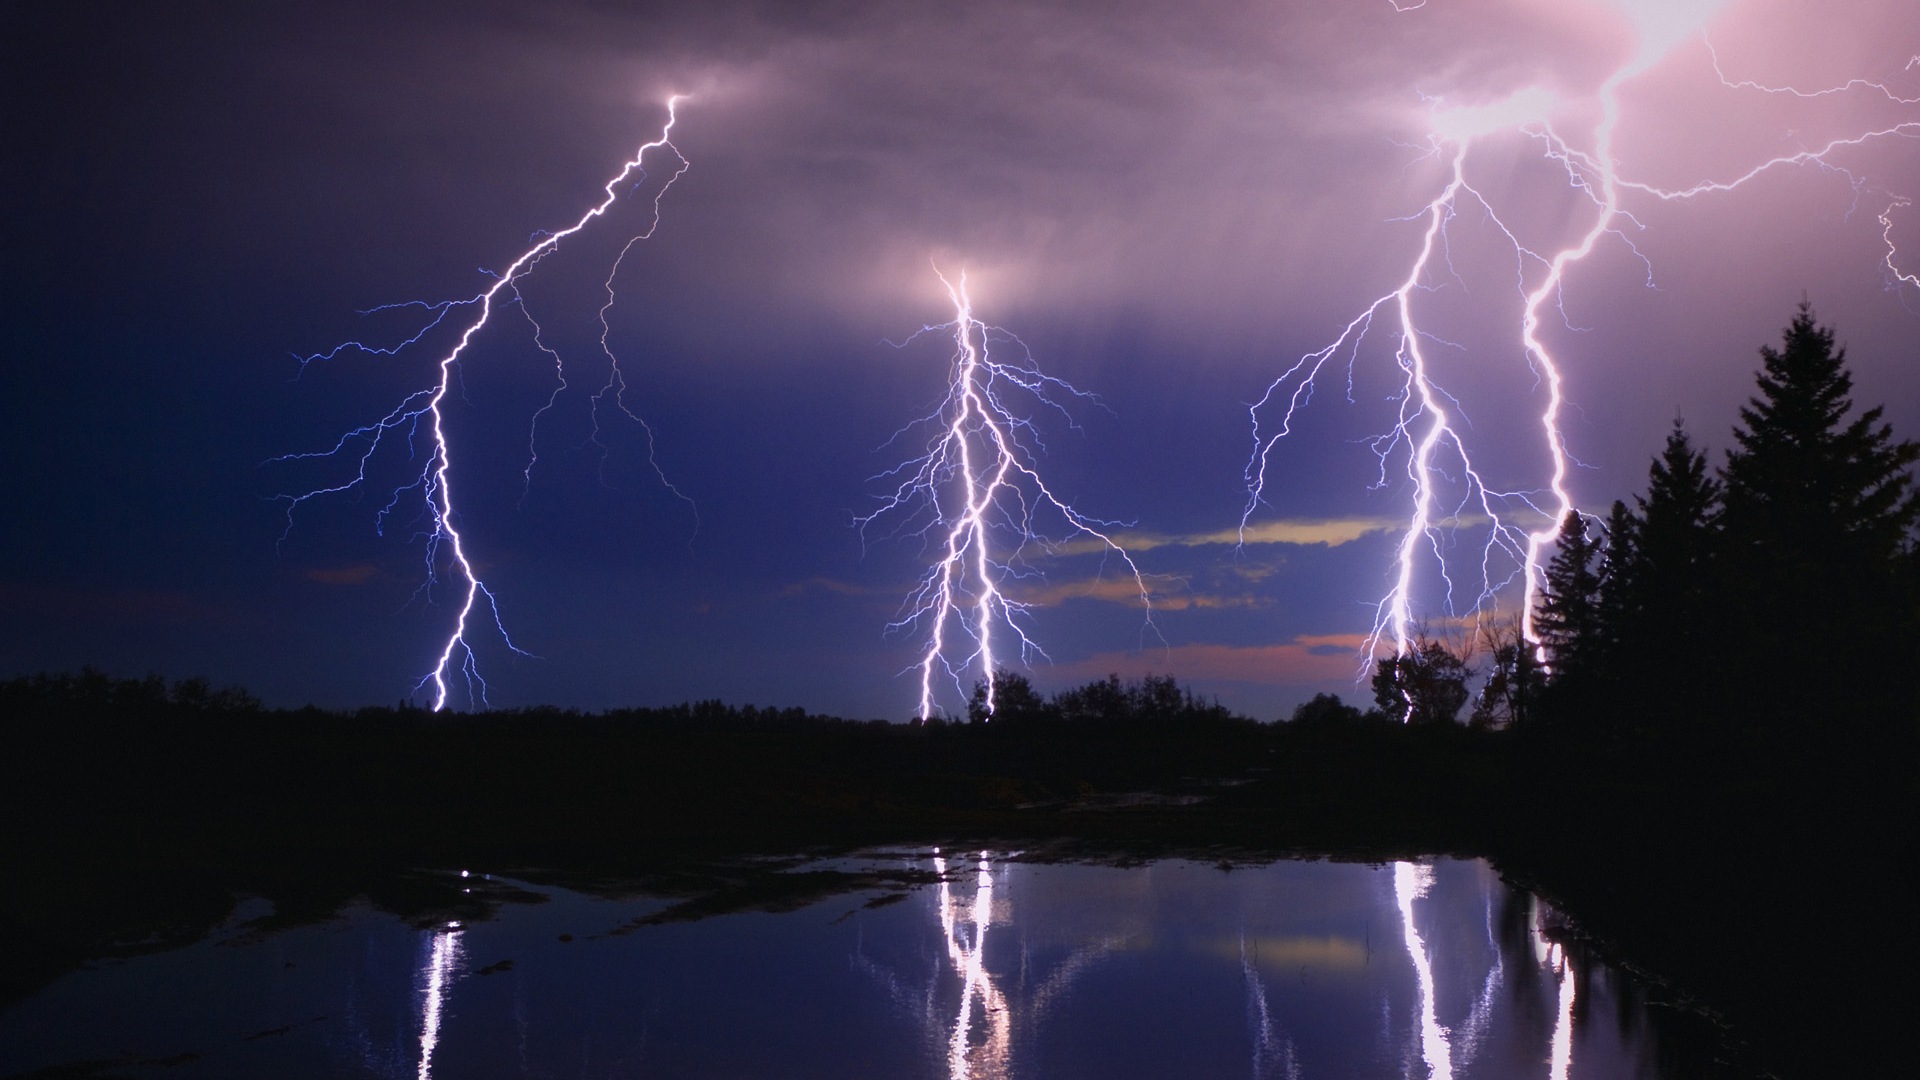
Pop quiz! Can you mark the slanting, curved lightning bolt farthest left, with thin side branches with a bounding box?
[271,94,687,711]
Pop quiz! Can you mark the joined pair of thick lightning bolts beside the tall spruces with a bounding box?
[1240,0,1920,671]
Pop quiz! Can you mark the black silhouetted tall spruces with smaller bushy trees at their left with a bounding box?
[1359,295,1920,753]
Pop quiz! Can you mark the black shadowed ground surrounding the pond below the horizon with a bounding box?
[0,684,1916,1078]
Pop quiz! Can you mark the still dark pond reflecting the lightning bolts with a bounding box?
[0,851,1689,1080]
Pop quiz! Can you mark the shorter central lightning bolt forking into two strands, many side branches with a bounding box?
[854,269,1152,719]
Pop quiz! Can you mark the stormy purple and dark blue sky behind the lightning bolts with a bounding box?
[0,0,1920,719]
